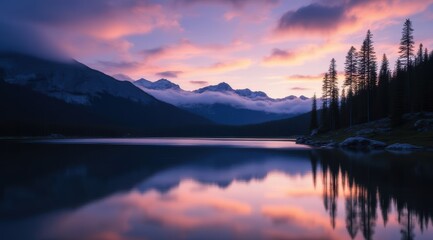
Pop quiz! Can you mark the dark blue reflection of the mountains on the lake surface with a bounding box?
[0,144,309,219]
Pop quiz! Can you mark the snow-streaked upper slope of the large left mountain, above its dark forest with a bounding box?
[0,54,157,104]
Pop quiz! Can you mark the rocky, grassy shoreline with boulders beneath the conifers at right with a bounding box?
[296,112,433,151]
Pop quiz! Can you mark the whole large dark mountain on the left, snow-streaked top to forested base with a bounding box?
[0,53,211,134]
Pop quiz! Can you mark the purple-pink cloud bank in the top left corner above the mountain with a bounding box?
[0,0,179,57]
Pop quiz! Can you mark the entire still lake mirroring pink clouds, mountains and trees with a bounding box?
[0,139,433,240]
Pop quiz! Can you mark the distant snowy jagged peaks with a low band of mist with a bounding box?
[133,79,311,125]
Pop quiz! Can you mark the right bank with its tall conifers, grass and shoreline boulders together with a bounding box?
[308,19,433,150]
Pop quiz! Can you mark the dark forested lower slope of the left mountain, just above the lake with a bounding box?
[0,82,210,136]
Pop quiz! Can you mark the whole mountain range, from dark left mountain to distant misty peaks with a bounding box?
[0,53,310,137]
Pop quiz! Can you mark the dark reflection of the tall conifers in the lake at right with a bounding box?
[312,151,433,239]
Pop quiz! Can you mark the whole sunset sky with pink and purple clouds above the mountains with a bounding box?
[0,0,433,97]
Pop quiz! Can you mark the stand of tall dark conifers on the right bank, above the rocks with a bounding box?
[312,19,433,132]
